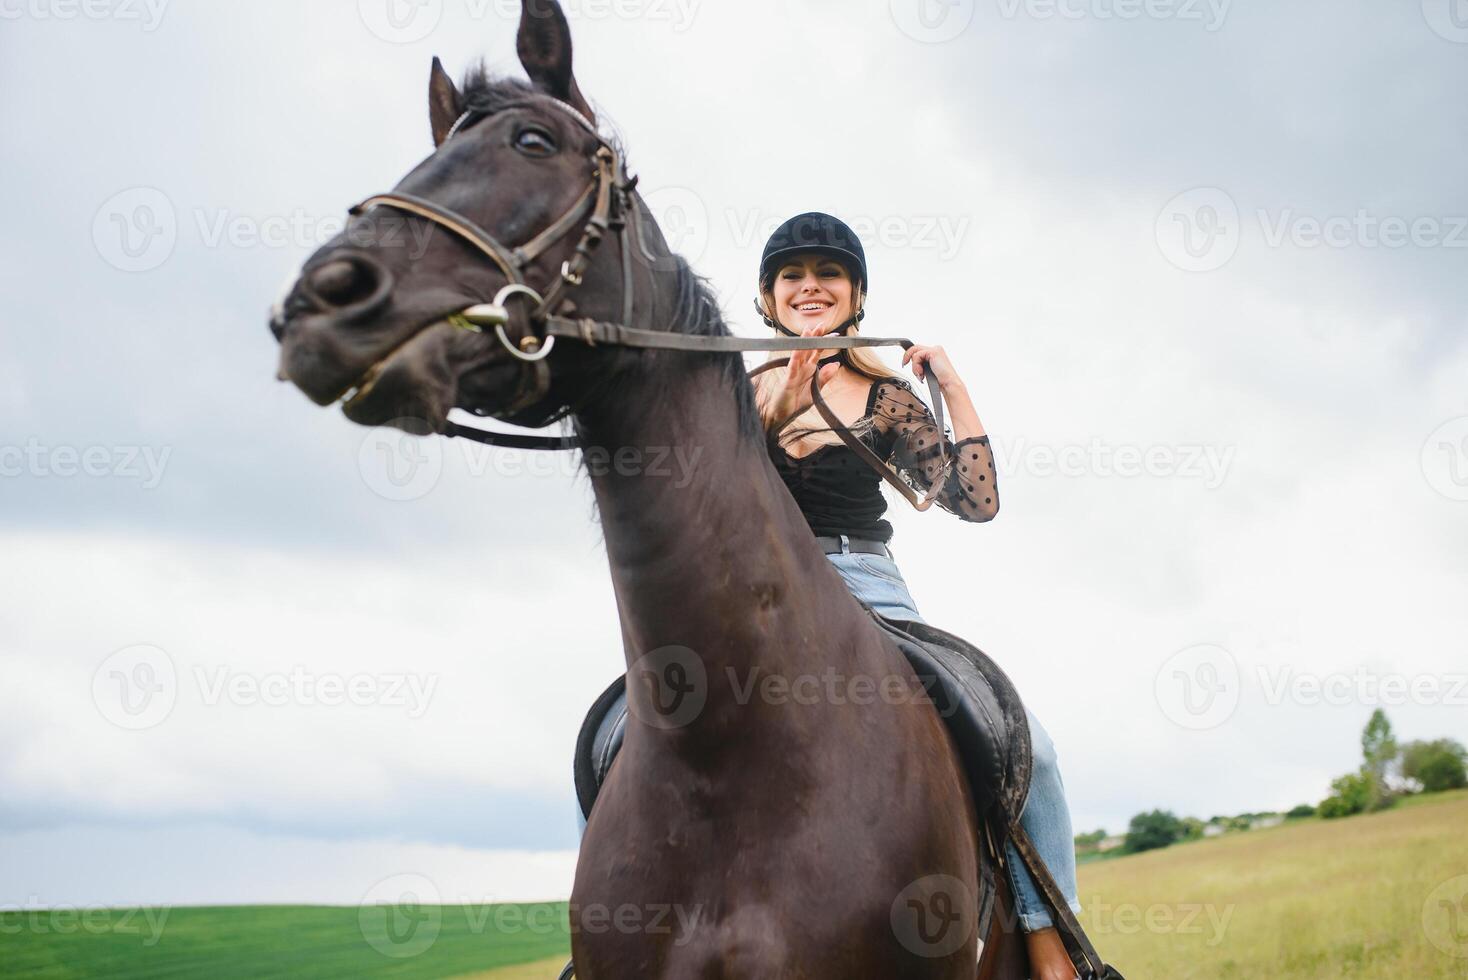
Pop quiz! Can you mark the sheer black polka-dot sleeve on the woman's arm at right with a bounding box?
[872,379,1000,522]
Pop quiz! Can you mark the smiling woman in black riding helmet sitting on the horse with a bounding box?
[756,213,1080,980]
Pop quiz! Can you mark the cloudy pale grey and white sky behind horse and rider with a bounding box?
[0,0,1468,907]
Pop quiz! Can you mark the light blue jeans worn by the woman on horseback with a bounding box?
[826,540,1080,932]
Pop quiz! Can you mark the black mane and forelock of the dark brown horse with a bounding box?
[459,60,765,440]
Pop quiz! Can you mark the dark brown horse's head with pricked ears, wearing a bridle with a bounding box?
[270,0,654,433]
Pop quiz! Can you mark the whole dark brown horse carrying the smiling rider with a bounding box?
[270,0,1028,980]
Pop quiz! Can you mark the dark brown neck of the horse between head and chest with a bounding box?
[578,355,863,712]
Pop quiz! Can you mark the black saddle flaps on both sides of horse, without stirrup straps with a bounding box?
[574,610,1031,819]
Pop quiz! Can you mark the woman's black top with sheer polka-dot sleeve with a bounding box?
[769,377,1000,543]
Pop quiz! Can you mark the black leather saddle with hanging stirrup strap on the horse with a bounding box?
[564,604,1123,980]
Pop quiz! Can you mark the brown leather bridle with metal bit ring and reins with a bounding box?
[349,100,953,511]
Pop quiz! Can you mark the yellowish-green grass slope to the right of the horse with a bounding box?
[1080,792,1468,980]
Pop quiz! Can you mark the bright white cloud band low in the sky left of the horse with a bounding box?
[0,534,621,839]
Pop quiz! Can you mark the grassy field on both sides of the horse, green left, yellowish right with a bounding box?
[11,792,1468,980]
